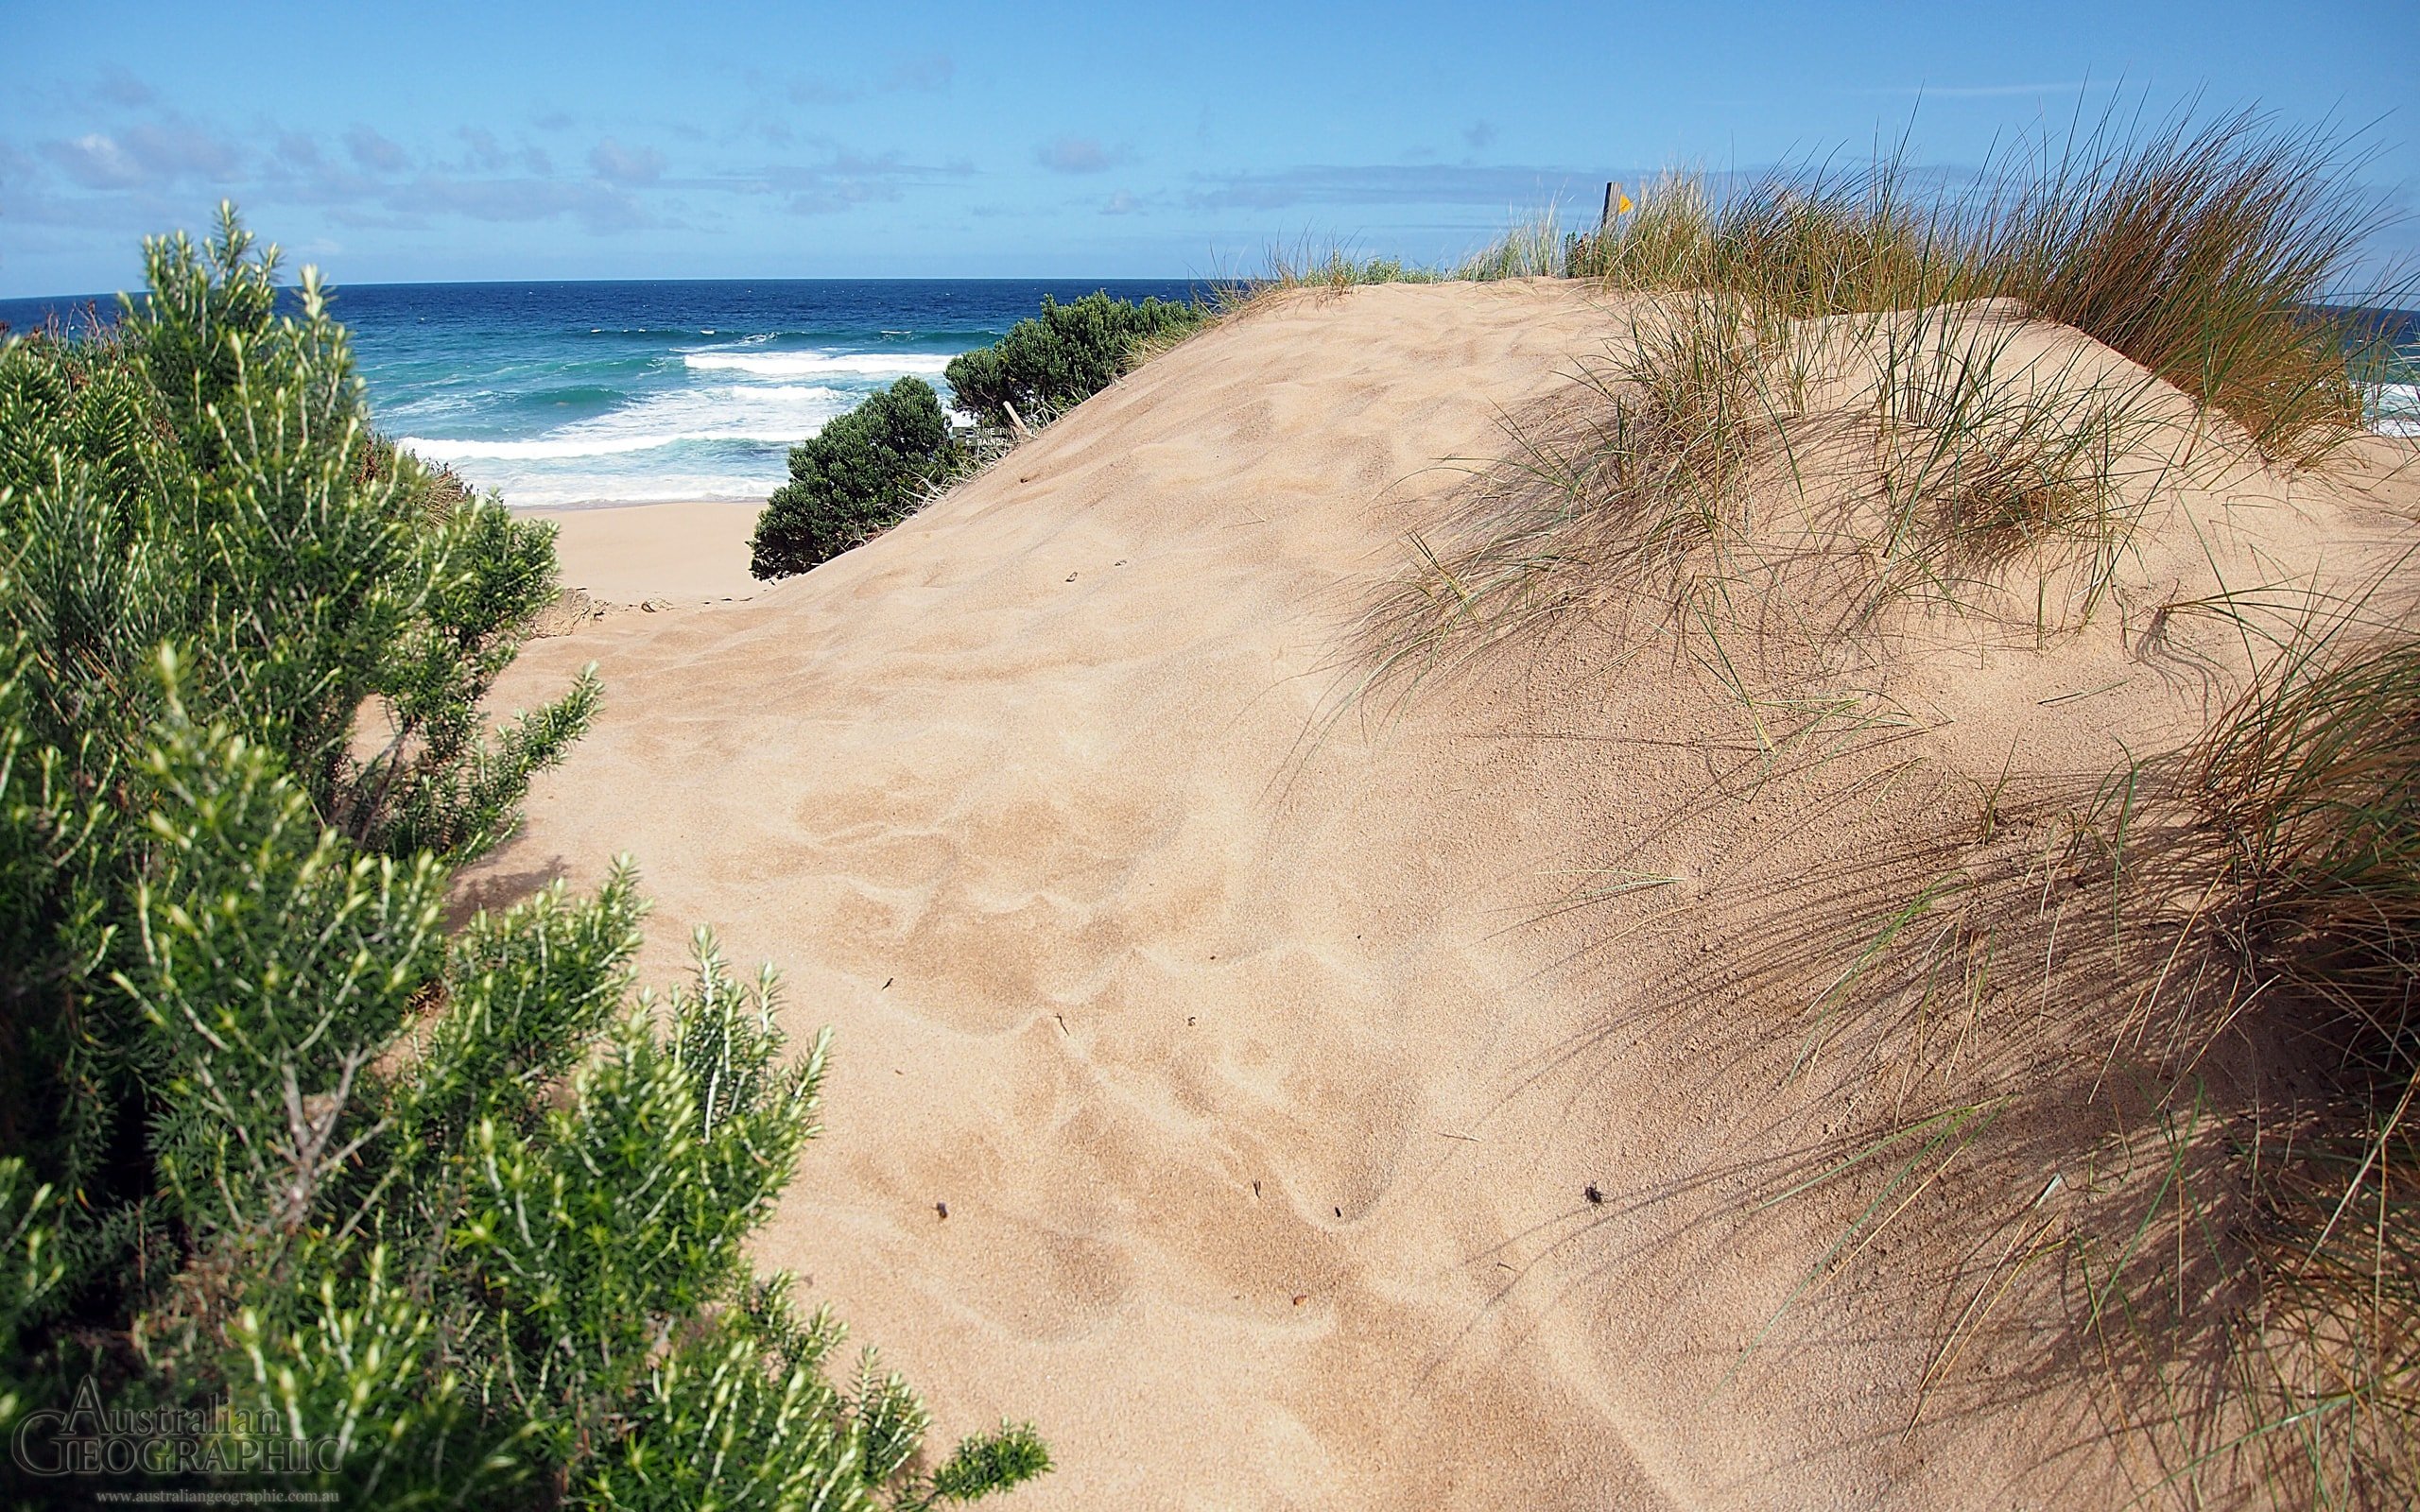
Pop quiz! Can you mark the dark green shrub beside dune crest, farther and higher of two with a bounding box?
[942,293,1210,426]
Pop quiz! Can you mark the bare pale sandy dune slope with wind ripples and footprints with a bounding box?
[470,285,2403,1507]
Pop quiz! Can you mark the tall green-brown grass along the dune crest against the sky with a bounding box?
[1564,112,2384,465]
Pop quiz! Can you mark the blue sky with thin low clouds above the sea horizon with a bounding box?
[0,0,2420,298]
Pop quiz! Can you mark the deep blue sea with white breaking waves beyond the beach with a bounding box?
[0,278,1205,508]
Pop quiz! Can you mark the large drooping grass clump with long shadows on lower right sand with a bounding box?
[1684,610,2420,1507]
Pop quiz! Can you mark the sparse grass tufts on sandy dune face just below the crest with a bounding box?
[1370,285,2183,668]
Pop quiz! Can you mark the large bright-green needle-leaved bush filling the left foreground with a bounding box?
[0,211,1047,1507]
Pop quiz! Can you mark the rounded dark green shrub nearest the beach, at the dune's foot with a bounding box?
[748,377,959,578]
